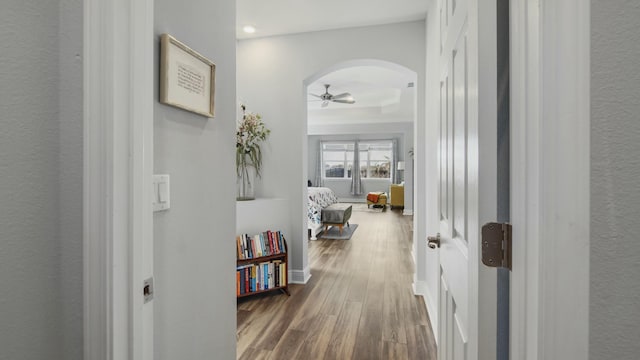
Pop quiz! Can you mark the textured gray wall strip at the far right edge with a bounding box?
[589,0,640,360]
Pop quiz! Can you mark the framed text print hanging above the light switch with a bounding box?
[160,34,216,118]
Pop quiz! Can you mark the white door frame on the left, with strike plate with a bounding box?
[83,0,154,360]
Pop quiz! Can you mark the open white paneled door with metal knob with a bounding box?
[430,0,496,360]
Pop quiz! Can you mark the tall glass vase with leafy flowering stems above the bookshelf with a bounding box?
[236,105,271,201]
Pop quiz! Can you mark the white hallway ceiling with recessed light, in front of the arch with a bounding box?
[236,0,429,39]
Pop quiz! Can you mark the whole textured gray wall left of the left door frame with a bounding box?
[0,0,82,359]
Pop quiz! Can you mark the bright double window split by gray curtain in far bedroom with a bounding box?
[322,140,393,179]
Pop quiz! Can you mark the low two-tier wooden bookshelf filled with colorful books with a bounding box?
[236,231,291,298]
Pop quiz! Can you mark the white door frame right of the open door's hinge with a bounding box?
[511,0,590,360]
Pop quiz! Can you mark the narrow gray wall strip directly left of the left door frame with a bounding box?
[58,0,84,360]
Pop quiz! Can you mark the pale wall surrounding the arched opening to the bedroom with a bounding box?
[237,21,424,278]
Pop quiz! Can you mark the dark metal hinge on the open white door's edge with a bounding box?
[482,223,511,270]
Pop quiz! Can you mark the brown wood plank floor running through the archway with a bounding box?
[237,204,436,360]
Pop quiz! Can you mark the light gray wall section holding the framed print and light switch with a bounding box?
[154,0,236,359]
